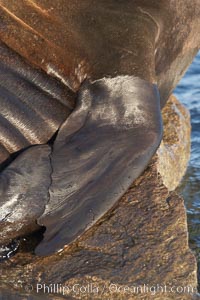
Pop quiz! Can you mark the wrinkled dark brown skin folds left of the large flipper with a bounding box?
[0,42,74,163]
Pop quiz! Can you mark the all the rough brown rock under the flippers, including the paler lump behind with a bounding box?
[0,97,198,300]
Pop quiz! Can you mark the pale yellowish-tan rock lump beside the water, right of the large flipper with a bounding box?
[157,95,191,191]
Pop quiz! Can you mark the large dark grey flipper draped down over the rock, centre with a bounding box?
[36,76,162,255]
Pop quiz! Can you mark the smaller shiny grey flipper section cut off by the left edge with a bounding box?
[0,145,52,245]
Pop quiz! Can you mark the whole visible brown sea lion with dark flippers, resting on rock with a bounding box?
[0,0,200,255]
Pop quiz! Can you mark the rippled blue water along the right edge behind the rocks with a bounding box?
[174,52,200,263]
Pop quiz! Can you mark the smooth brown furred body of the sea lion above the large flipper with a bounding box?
[0,0,200,102]
